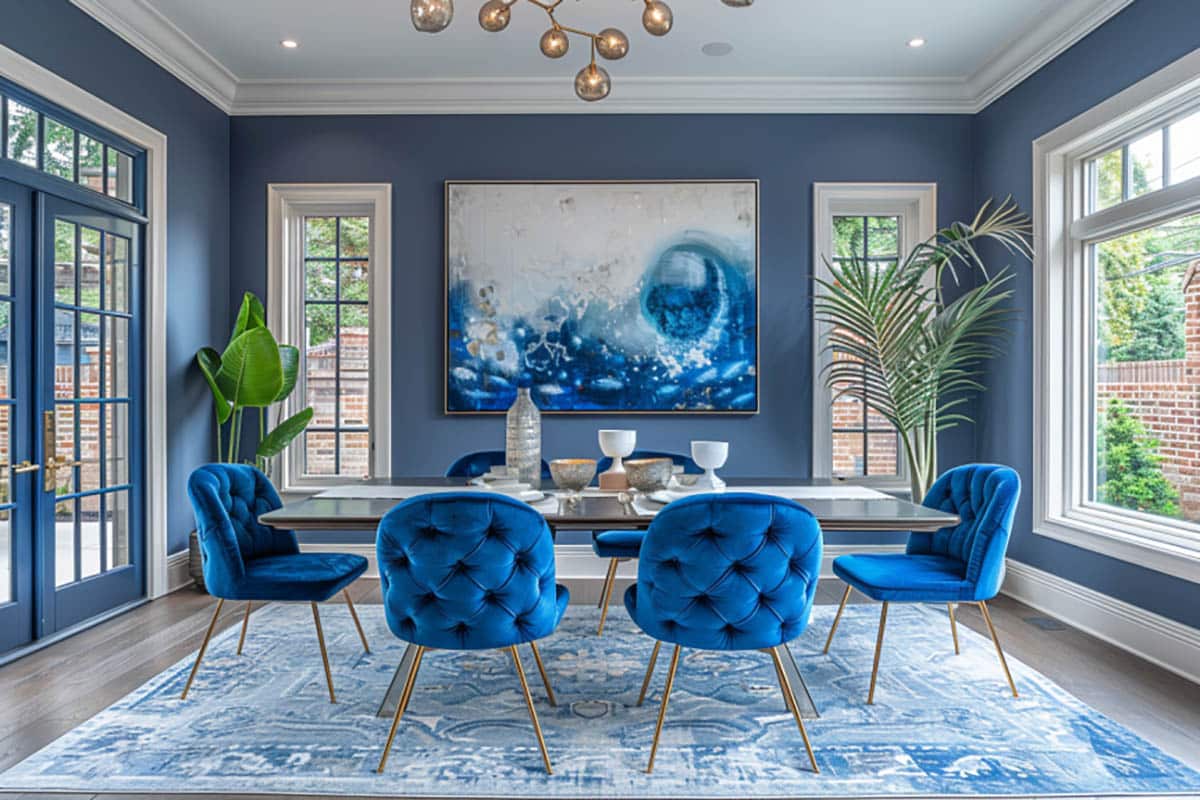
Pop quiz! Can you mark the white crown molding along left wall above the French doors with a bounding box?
[71,0,238,114]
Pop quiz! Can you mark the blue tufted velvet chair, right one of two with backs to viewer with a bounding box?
[625,493,822,772]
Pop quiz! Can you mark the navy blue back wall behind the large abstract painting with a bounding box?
[229,115,973,501]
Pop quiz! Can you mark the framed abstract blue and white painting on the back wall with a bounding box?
[446,180,758,414]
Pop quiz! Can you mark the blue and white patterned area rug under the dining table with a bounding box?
[0,603,1200,799]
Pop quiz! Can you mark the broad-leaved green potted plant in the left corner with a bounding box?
[188,291,313,589]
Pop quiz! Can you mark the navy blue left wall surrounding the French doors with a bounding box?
[0,0,229,551]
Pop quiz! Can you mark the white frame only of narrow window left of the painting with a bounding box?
[266,184,391,494]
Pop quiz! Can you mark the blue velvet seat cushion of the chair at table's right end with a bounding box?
[833,553,986,603]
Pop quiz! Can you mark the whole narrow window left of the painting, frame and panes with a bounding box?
[268,185,391,491]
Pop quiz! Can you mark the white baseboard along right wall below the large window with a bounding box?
[1002,559,1200,684]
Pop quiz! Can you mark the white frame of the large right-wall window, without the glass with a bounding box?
[1033,49,1200,582]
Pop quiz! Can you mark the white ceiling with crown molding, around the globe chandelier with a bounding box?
[73,0,1129,113]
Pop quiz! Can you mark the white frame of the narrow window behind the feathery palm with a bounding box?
[812,182,937,491]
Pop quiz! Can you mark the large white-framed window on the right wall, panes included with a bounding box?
[1033,47,1200,581]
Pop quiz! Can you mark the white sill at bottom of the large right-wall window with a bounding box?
[1034,506,1200,583]
